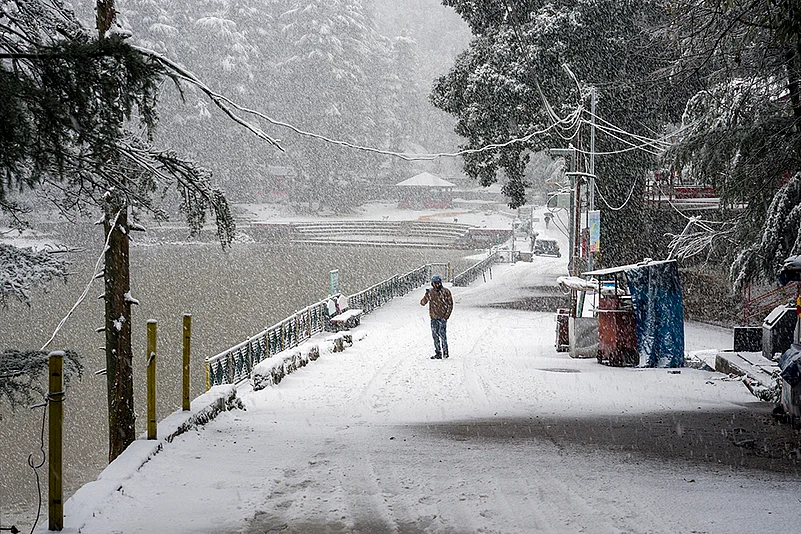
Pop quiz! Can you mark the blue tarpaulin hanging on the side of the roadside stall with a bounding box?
[626,261,684,367]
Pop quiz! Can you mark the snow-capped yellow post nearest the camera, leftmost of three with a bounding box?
[47,350,64,530]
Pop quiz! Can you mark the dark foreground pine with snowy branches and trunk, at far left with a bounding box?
[0,0,235,460]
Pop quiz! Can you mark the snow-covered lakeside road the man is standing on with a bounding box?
[56,262,801,534]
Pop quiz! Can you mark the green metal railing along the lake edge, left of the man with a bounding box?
[204,263,450,390]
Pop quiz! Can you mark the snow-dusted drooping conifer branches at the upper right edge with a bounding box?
[669,0,801,291]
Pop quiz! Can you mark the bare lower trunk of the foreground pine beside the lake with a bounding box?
[104,202,136,462]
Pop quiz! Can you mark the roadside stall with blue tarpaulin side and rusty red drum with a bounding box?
[584,260,684,367]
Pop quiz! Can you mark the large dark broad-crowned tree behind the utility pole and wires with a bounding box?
[432,0,682,265]
